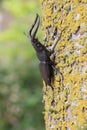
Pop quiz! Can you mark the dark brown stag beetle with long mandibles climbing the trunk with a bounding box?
[28,14,61,86]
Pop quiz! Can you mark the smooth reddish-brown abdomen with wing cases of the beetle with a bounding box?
[40,62,53,86]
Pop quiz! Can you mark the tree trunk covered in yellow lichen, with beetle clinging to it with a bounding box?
[41,0,87,130]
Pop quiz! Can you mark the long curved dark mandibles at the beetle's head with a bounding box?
[29,14,40,39]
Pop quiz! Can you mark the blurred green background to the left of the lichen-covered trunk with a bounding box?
[0,0,44,130]
